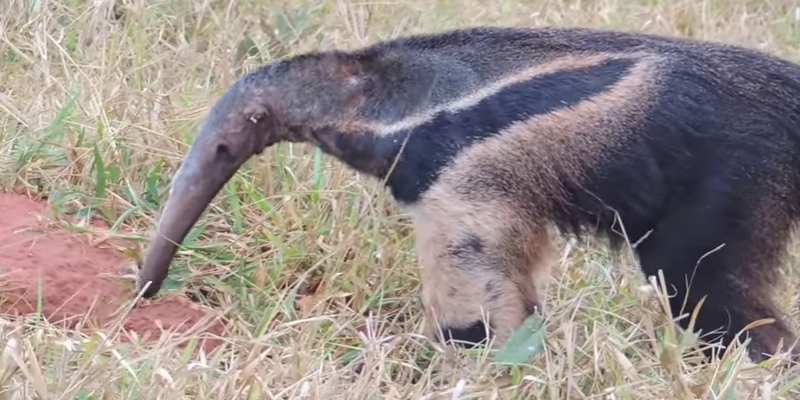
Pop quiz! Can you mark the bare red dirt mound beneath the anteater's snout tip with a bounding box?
[0,192,222,350]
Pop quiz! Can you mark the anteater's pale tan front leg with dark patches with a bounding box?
[412,197,556,346]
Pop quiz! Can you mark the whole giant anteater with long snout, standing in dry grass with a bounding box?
[134,24,800,359]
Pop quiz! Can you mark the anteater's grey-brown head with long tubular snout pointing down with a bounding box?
[137,52,371,297]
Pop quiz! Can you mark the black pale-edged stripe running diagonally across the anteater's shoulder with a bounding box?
[320,58,636,204]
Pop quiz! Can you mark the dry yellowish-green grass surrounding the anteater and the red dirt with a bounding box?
[0,0,800,400]
